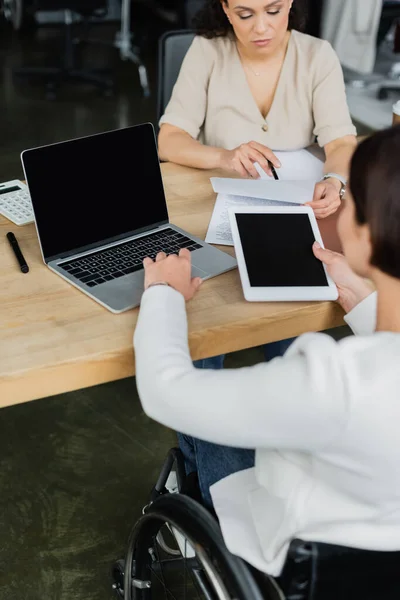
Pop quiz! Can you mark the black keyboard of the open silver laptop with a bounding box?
[58,229,202,287]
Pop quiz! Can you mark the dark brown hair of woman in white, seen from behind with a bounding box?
[349,125,400,279]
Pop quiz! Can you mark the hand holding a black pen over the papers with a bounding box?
[221,142,281,179]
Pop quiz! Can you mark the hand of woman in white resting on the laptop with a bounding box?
[143,248,203,301]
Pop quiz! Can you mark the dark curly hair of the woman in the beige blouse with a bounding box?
[192,0,307,39]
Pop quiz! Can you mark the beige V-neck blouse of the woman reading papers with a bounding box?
[160,31,356,150]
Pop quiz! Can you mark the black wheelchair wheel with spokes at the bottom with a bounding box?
[113,494,273,600]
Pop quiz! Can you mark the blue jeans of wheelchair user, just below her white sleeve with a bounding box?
[178,433,254,507]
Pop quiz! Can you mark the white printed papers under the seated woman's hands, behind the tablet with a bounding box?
[206,150,323,246]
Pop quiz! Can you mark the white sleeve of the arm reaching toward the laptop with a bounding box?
[134,286,346,451]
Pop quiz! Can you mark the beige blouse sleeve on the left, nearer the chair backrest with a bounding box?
[159,36,214,139]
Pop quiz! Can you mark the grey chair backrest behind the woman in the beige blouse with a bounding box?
[157,29,195,123]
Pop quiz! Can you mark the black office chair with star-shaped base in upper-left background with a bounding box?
[13,0,113,100]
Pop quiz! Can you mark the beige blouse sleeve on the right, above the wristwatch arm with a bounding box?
[313,41,357,147]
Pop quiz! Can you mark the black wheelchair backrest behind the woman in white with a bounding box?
[279,540,400,600]
